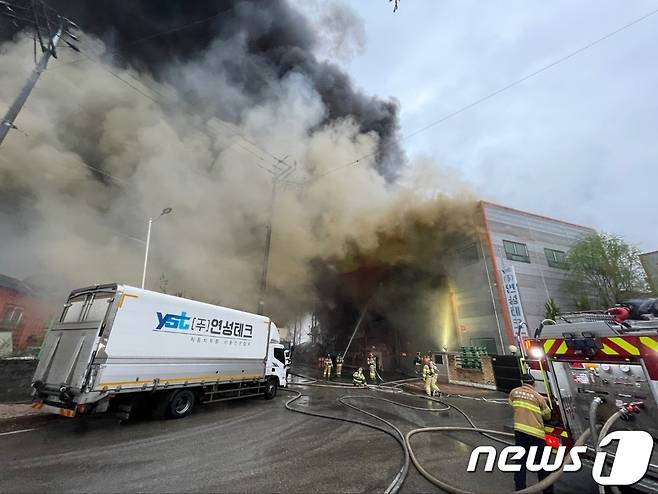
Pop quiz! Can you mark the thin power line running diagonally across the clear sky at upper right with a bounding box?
[308,9,658,185]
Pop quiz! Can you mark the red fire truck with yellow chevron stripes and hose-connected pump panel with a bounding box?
[519,312,658,492]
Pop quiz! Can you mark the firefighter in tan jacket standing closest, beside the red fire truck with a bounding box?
[509,374,553,494]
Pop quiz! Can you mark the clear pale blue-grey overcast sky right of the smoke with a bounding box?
[324,0,658,251]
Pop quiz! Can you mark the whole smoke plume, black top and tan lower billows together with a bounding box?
[0,0,474,322]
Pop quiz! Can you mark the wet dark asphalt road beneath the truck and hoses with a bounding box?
[0,368,596,494]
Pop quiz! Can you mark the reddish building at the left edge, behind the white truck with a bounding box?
[0,287,57,353]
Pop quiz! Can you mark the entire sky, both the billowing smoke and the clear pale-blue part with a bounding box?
[0,0,658,321]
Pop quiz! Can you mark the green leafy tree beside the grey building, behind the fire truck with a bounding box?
[567,233,647,308]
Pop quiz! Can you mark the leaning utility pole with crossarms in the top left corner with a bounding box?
[0,0,80,145]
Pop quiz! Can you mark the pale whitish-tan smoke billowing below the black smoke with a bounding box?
[0,29,473,320]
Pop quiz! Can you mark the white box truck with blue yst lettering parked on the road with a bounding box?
[32,284,287,418]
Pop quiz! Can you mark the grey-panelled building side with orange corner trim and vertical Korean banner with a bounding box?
[446,201,596,354]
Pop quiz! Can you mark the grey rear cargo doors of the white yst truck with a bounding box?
[34,291,114,396]
